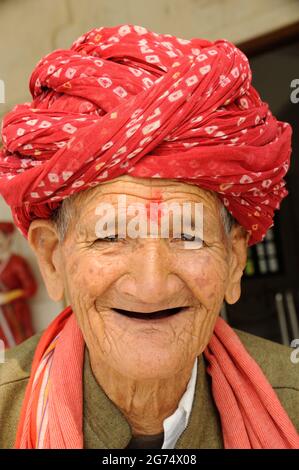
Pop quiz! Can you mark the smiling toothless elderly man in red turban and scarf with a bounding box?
[0,25,299,449]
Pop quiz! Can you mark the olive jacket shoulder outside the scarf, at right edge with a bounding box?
[234,330,299,431]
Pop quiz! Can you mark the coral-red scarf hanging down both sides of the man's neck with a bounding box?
[15,307,299,449]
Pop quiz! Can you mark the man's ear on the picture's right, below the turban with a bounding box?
[224,224,249,304]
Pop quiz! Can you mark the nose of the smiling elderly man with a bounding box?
[121,238,183,307]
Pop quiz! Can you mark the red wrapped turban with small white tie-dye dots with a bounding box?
[0,25,292,244]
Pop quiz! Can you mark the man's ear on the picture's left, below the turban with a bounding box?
[28,219,64,301]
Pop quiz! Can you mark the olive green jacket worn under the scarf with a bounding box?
[0,330,299,449]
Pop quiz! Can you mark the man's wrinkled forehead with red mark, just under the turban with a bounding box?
[68,175,223,242]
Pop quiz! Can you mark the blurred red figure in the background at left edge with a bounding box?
[0,222,37,348]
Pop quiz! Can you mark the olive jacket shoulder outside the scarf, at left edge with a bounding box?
[0,333,41,448]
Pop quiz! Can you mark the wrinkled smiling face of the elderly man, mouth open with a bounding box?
[55,176,239,379]
